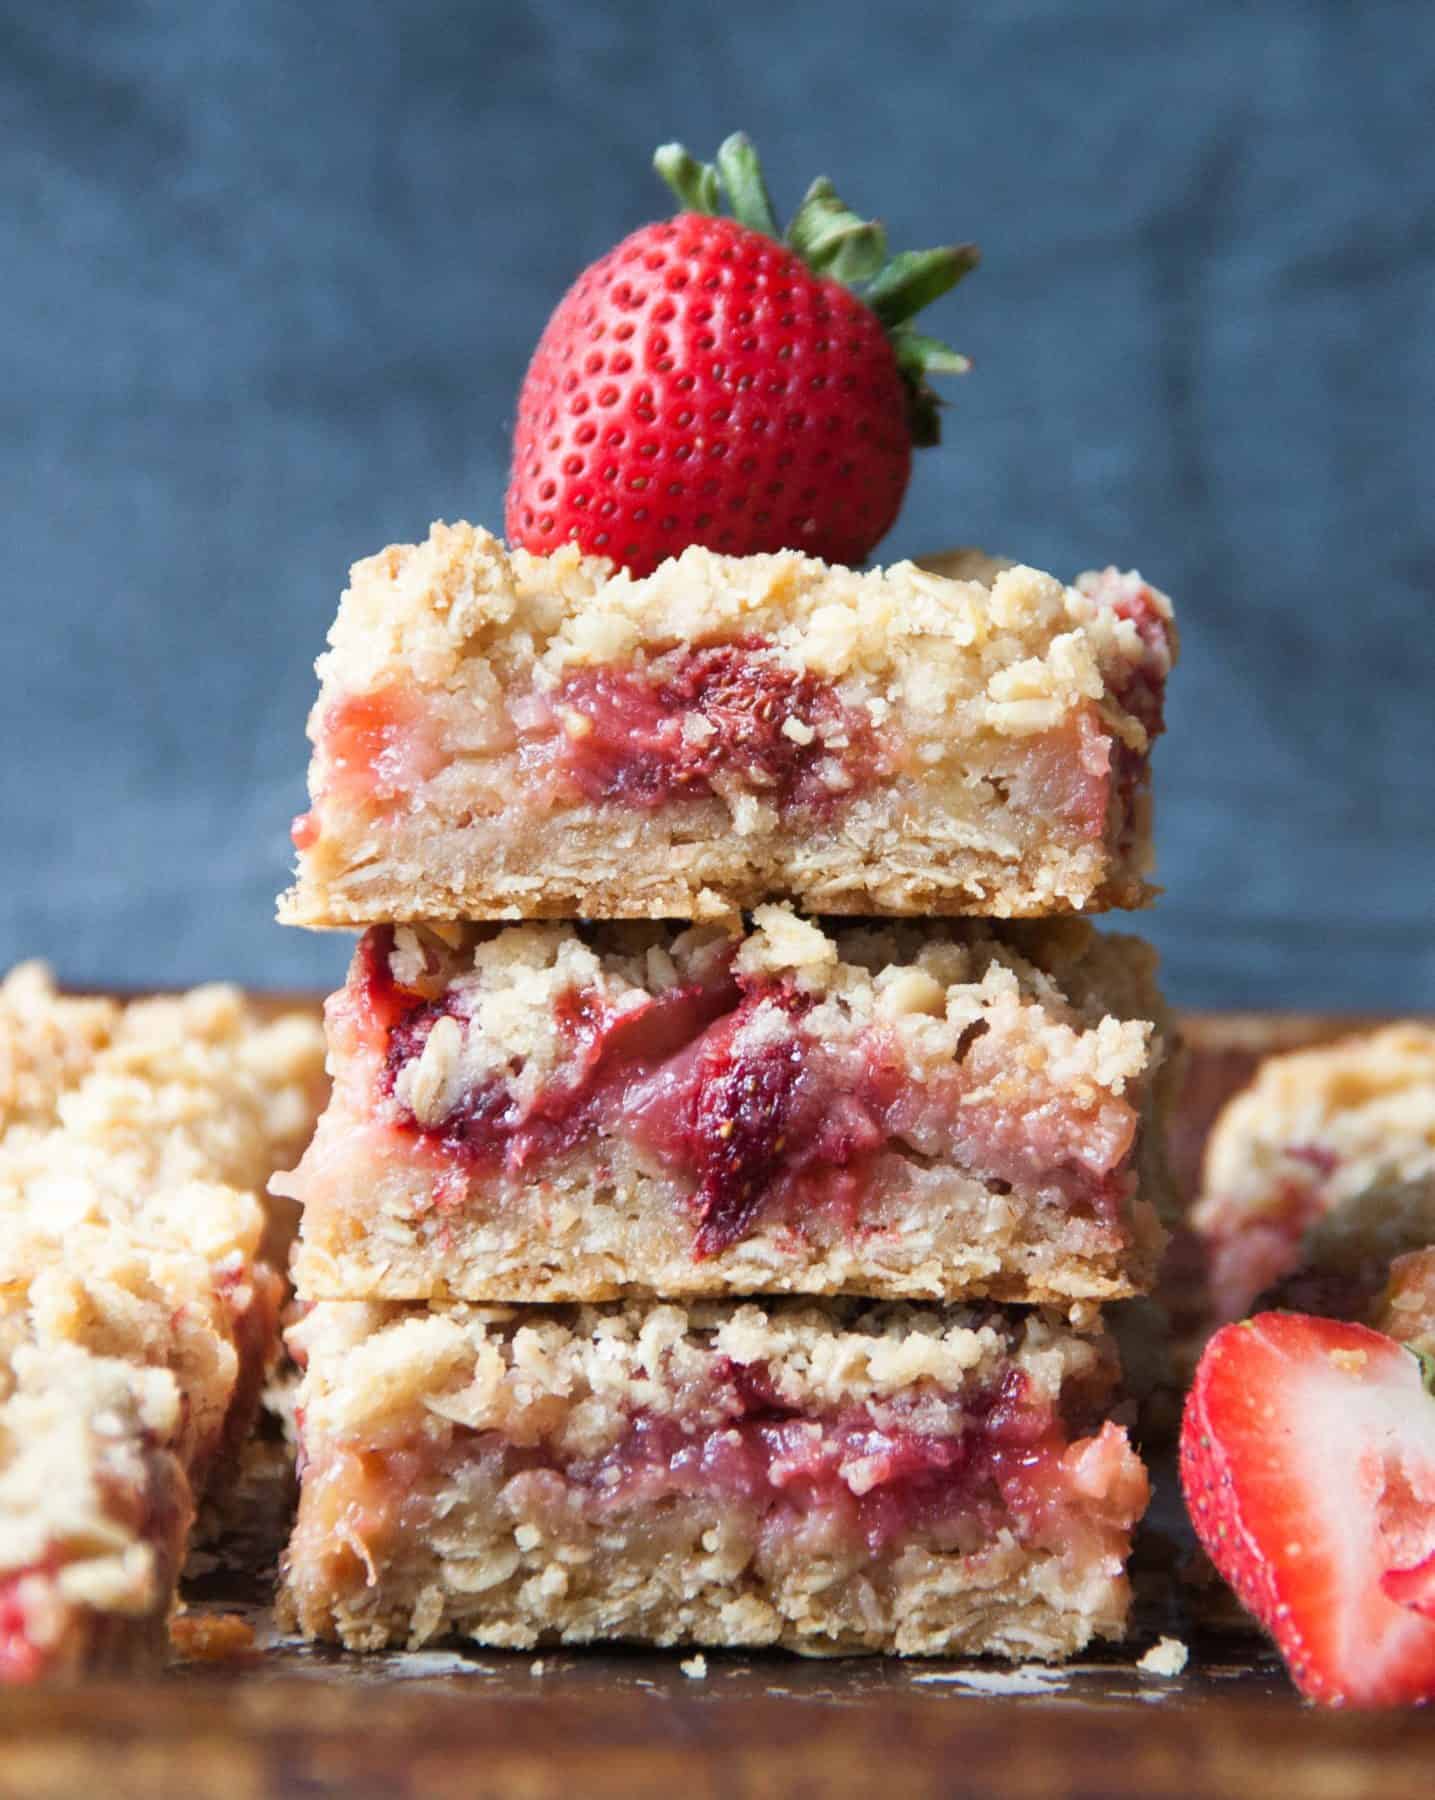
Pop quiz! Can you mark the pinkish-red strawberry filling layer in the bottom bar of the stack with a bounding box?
[304,1359,1149,1568]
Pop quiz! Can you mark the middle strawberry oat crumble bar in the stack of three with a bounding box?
[286,907,1165,1305]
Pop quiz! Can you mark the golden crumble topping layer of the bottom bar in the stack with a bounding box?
[290,1300,1113,1456]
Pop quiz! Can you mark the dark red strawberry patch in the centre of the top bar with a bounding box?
[542,637,880,812]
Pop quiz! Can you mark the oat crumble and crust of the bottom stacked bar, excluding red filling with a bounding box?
[281,1301,1147,1660]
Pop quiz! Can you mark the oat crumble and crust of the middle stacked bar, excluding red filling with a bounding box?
[286,907,1170,1305]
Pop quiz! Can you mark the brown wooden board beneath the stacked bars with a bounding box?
[0,1013,1435,1800]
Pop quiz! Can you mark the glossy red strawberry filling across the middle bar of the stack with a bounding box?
[358,929,1138,1258]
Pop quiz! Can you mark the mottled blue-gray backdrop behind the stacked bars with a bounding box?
[0,0,1435,1006]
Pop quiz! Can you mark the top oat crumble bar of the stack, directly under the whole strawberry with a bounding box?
[281,524,1174,925]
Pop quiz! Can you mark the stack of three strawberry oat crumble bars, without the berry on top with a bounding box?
[271,526,1174,1658]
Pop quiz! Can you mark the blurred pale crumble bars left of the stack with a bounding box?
[0,965,322,1679]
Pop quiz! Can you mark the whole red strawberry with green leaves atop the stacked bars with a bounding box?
[506,135,978,574]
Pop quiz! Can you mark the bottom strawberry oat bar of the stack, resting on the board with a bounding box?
[283,1300,1149,1660]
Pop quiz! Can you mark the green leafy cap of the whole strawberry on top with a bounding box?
[654,131,981,445]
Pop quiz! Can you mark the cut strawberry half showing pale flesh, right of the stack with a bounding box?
[1181,1312,1435,1706]
